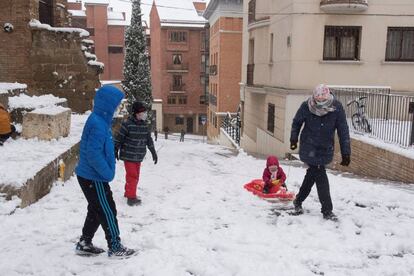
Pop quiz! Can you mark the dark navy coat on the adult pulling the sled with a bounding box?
[290,100,351,165]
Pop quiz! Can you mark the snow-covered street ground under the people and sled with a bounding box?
[0,135,414,276]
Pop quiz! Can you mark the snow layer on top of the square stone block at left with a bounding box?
[9,94,66,110]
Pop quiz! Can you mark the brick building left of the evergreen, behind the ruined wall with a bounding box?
[68,0,129,80]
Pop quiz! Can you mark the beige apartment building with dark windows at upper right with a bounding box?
[240,0,414,156]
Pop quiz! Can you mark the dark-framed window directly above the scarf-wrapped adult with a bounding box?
[323,26,361,60]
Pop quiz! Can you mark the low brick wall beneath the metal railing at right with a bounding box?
[331,139,414,183]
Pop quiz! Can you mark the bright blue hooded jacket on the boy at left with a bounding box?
[75,86,124,182]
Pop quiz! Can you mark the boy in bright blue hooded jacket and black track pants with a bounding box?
[75,86,135,257]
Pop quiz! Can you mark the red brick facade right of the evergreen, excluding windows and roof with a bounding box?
[150,3,207,133]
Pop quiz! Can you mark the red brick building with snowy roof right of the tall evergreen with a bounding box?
[150,0,209,134]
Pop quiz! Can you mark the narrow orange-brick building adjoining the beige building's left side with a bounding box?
[204,0,243,140]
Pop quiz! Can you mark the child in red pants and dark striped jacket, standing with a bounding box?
[115,102,158,206]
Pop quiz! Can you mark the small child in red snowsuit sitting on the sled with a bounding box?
[262,155,287,194]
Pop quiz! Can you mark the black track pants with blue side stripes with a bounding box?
[78,176,120,249]
